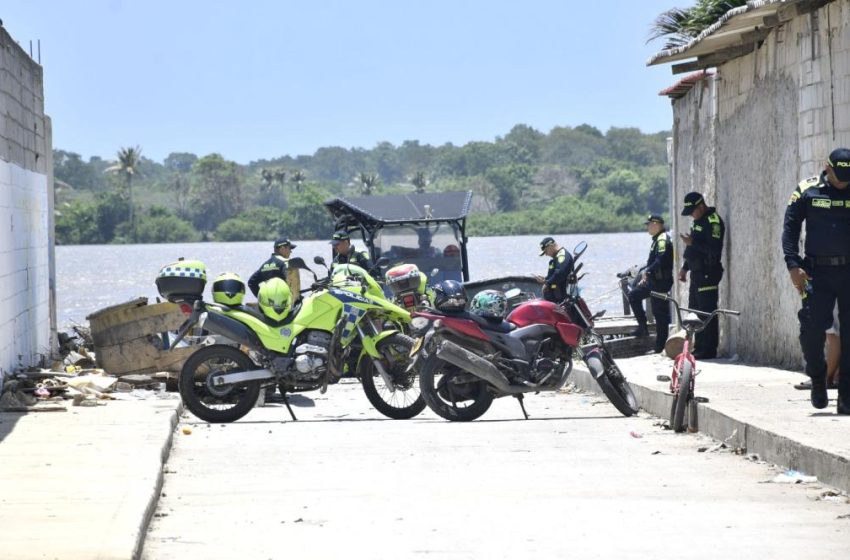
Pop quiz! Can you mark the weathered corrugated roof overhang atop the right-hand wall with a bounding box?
[647,0,820,72]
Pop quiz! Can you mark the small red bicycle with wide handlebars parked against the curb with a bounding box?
[650,292,741,432]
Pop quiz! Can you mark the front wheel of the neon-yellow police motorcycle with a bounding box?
[359,333,425,420]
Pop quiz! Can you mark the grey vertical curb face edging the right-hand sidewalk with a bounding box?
[570,364,850,492]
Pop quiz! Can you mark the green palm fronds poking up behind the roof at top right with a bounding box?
[649,0,747,49]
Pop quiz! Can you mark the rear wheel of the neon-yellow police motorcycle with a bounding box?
[178,345,260,423]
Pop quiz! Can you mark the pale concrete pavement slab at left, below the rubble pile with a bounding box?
[0,393,180,560]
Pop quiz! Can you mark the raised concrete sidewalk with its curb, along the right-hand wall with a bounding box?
[573,354,850,491]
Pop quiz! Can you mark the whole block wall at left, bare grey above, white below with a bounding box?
[0,27,55,383]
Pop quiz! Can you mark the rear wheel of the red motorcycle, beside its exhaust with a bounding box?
[419,354,493,422]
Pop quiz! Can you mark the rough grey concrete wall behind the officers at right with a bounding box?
[672,0,850,367]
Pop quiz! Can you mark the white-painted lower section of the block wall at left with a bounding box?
[0,160,50,372]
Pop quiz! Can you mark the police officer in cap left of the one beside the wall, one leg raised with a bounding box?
[629,214,673,352]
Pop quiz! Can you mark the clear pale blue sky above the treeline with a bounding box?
[0,0,692,164]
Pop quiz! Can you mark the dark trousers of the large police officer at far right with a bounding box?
[797,265,850,403]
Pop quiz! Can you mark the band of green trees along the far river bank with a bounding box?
[54,124,668,244]
